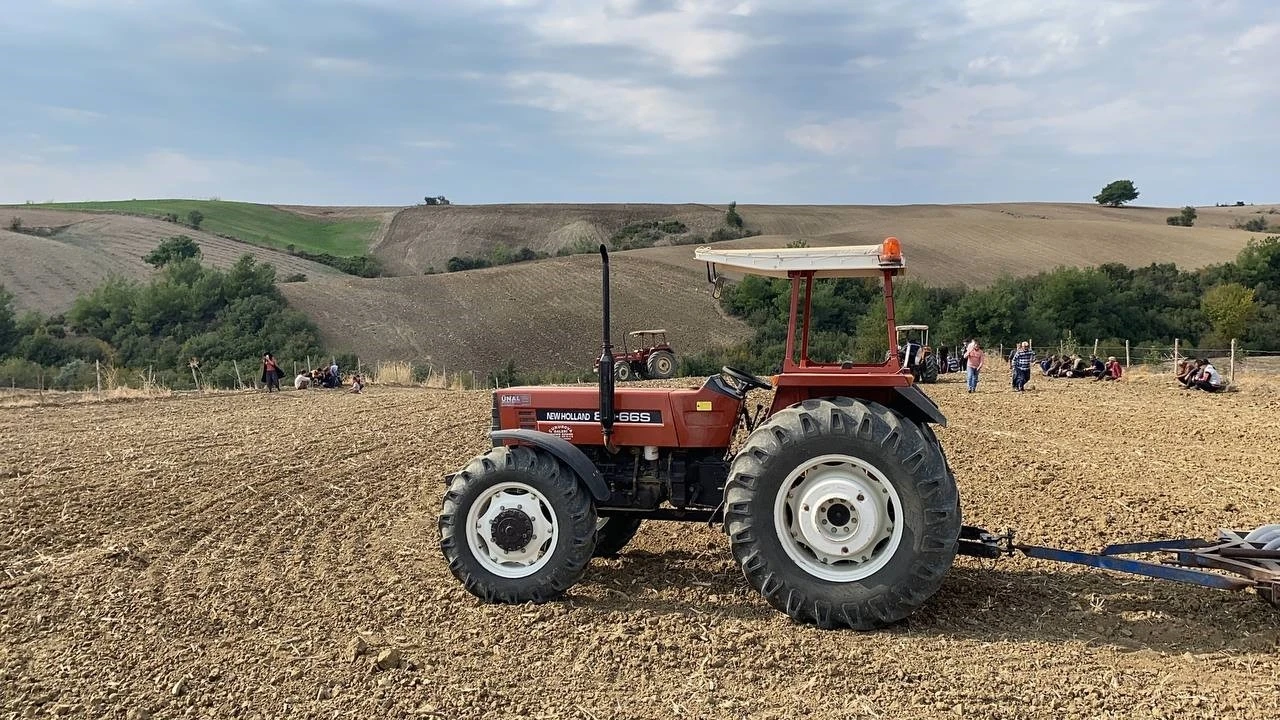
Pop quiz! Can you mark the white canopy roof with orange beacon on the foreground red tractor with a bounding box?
[694,237,906,278]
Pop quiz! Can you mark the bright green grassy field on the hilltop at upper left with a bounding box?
[8,200,397,256]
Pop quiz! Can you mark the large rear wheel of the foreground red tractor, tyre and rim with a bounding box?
[724,397,960,630]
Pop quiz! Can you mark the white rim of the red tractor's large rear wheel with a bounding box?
[773,455,902,583]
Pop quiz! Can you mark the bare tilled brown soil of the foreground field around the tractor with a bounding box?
[0,372,1280,719]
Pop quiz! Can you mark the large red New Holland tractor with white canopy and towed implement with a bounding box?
[439,237,1280,629]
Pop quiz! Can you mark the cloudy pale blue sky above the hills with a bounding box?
[0,0,1280,205]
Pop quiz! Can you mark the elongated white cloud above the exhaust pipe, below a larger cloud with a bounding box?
[507,73,716,141]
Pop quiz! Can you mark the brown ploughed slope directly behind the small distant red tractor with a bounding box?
[280,247,750,374]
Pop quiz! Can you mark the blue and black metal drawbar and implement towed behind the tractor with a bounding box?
[959,525,1280,607]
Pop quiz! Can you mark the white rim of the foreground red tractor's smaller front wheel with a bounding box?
[467,483,559,578]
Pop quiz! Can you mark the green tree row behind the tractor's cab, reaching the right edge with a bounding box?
[682,236,1280,374]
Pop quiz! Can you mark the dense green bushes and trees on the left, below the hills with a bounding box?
[0,236,321,387]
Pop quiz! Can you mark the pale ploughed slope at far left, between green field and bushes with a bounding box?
[0,208,339,313]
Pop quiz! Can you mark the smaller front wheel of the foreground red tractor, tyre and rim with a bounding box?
[439,446,596,603]
